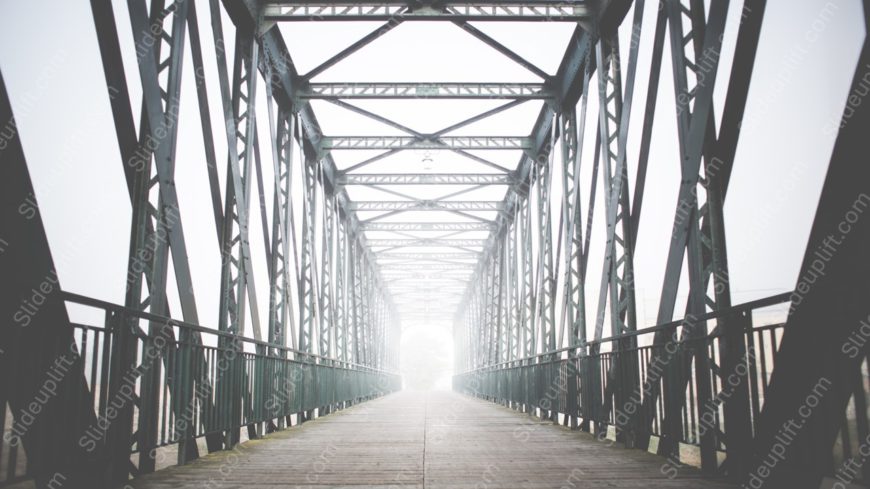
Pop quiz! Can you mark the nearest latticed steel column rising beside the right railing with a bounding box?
[659,0,730,472]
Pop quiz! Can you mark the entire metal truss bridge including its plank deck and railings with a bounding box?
[0,0,870,489]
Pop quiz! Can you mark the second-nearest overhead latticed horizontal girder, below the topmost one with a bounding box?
[300,82,551,100]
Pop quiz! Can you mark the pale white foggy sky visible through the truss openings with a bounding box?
[0,0,864,384]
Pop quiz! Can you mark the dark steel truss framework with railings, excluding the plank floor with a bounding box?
[0,0,870,487]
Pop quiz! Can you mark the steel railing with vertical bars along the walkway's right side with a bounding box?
[453,293,790,470]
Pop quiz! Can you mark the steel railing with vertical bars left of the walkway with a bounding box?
[0,292,401,486]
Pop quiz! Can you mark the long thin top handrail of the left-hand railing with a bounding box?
[58,290,399,375]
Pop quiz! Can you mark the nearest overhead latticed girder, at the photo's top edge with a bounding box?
[263,0,590,22]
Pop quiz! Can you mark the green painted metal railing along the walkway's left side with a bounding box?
[62,292,402,462]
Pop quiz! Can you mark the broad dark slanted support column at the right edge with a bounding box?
[745,32,870,489]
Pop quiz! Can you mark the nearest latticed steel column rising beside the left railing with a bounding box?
[126,0,197,473]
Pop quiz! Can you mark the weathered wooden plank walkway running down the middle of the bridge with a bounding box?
[128,392,736,489]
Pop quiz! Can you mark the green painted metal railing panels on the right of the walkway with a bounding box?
[453,294,790,468]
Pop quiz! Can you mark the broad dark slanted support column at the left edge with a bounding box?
[0,70,104,487]
